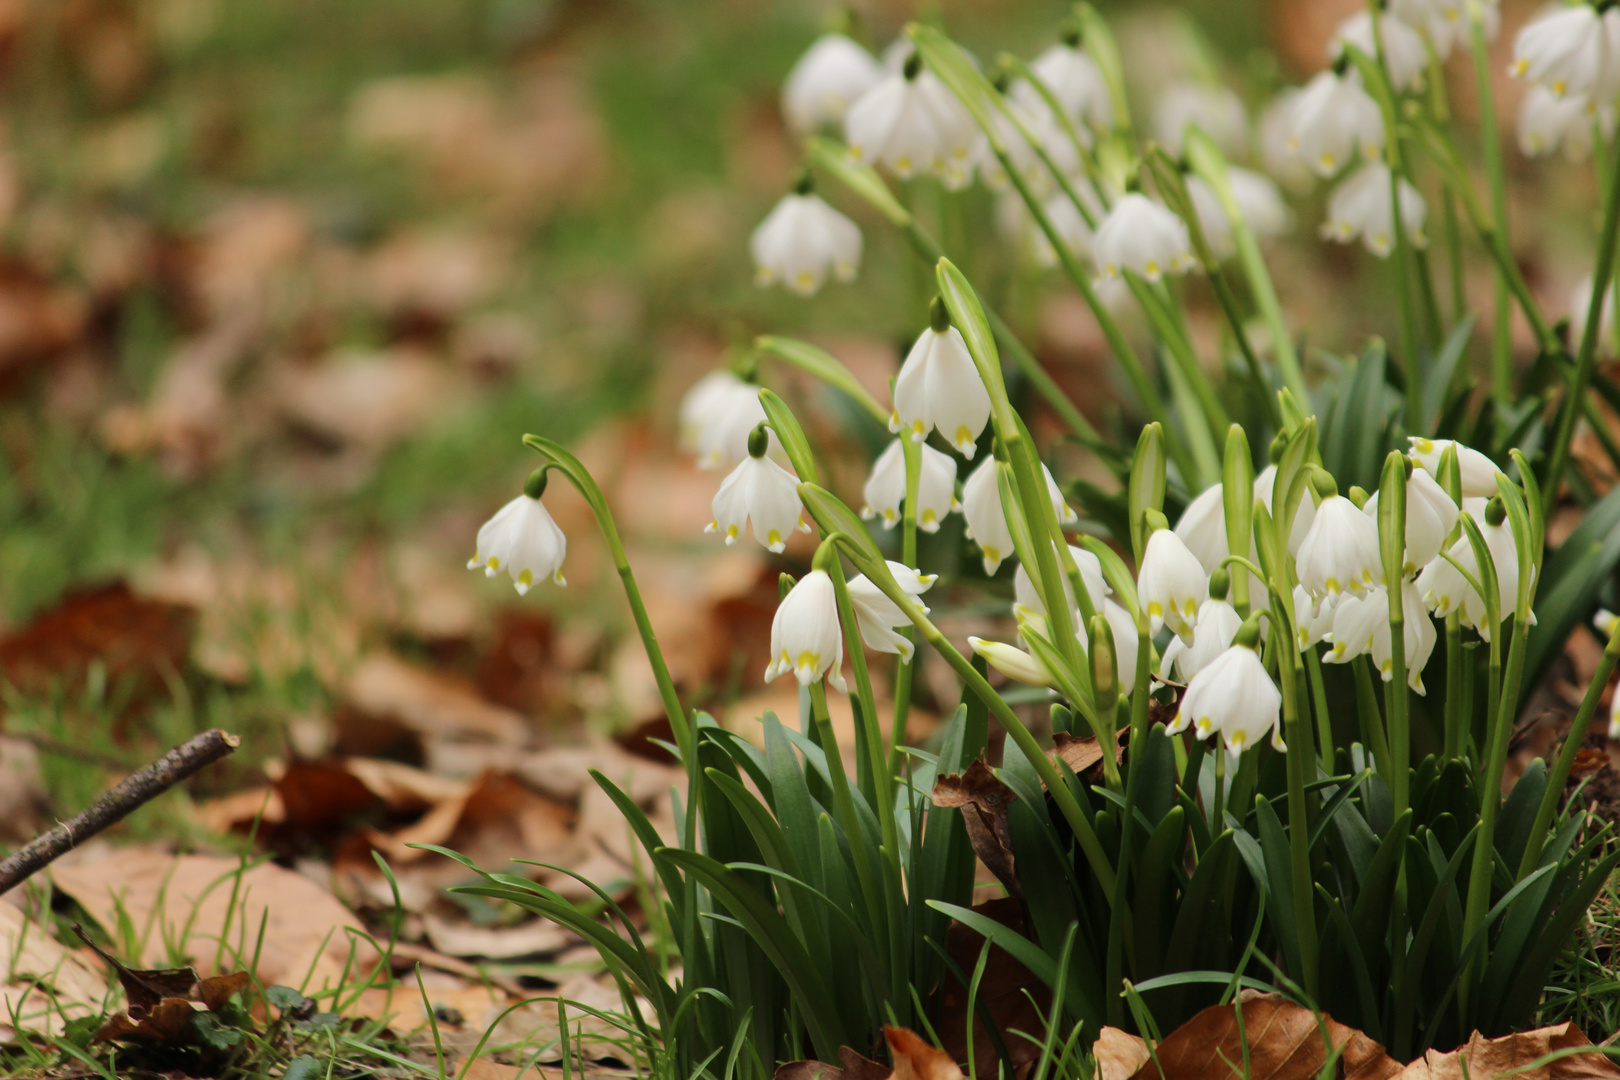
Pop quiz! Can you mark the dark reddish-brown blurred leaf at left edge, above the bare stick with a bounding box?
[0,581,194,701]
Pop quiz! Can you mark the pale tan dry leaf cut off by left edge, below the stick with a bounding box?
[0,900,107,1043]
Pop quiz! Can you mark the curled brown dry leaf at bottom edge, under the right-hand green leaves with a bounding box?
[1132,994,1401,1080]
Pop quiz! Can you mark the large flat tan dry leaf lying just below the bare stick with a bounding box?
[50,847,376,993]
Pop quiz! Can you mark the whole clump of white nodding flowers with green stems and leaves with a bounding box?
[447,0,1620,1077]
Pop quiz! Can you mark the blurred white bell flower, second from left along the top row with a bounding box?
[844,58,978,189]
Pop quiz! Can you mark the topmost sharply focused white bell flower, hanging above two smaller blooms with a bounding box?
[889,318,990,461]
